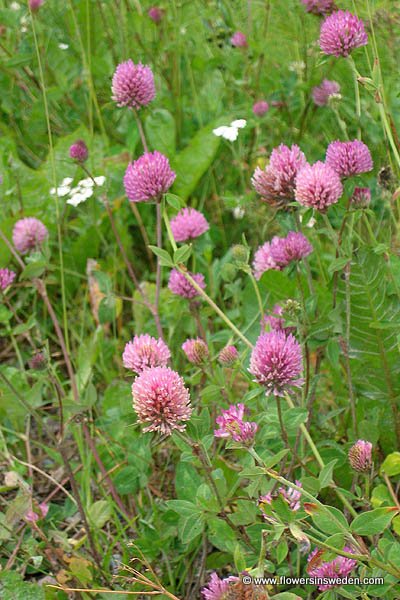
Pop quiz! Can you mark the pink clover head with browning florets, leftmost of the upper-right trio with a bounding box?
[251,144,307,204]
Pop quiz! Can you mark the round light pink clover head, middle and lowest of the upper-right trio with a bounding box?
[295,161,343,212]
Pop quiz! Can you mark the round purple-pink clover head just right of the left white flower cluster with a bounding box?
[124,150,176,202]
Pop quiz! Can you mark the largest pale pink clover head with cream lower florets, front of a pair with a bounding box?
[132,367,192,435]
